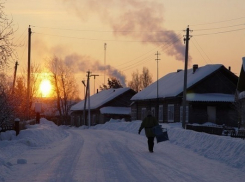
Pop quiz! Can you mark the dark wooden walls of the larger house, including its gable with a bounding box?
[132,67,238,126]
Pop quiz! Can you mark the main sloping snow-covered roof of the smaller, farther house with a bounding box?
[70,87,130,111]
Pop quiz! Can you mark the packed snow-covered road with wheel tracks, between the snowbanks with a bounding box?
[2,125,245,182]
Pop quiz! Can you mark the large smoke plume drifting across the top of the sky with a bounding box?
[60,0,189,61]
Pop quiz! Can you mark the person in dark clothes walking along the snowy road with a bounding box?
[138,110,159,153]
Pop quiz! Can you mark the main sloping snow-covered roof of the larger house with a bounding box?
[131,64,223,100]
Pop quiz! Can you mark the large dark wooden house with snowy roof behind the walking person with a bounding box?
[131,64,238,126]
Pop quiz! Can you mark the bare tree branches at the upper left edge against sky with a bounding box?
[0,2,15,70]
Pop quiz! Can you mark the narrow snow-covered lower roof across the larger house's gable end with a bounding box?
[186,93,235,102]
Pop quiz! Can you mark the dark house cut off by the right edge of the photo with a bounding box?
[236,57,245,127]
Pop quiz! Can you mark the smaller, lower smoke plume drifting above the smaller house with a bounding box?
[64,54,126,87]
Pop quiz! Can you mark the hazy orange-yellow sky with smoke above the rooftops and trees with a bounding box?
[5,0,245,97]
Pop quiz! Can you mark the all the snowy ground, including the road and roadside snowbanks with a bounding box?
[0,119,245,182]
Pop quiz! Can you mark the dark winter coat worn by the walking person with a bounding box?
[139,115,159,137]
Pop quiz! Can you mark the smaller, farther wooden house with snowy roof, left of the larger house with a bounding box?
[70,87,136,126]
